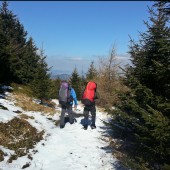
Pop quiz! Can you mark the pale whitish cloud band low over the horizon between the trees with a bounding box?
[46,54,130,74]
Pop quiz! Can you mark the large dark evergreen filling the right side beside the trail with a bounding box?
[115,2,170,169]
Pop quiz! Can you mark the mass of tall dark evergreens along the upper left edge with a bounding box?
[0,1,51,101]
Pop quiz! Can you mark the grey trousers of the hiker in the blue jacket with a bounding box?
[60,105,73,126]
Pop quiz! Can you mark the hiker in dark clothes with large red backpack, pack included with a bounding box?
[82,81,99,130]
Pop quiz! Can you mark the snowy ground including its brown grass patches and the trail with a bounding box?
[0,85,122,170]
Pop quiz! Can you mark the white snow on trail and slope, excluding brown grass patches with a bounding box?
[0,88,121,170]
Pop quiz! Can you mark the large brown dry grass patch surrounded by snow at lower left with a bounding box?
[0,118,44,163]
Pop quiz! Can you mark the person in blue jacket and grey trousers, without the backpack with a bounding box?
[60,83,78,128]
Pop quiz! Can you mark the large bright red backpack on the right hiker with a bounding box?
[82,81,97,105]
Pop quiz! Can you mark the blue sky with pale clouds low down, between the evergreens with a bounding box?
[4,1,153,73]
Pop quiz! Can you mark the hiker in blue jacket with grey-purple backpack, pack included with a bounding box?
[59,81,78,128]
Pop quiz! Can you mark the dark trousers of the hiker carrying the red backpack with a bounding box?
[83,105,96,126]
